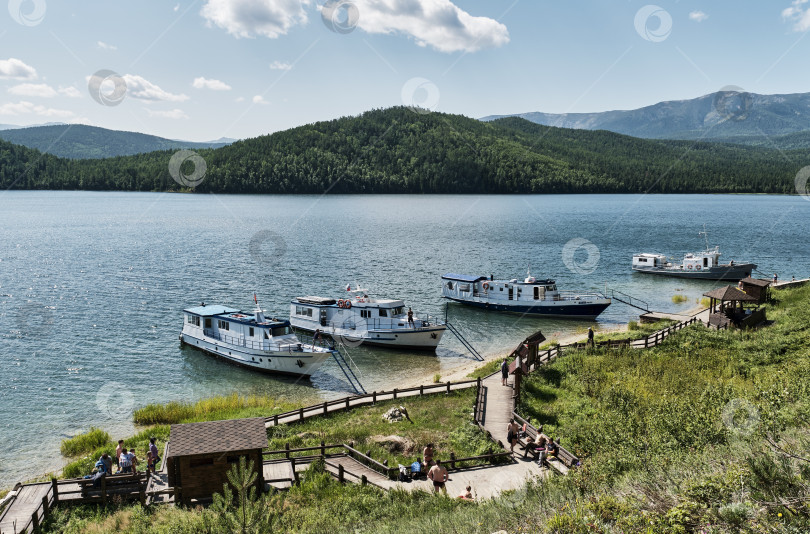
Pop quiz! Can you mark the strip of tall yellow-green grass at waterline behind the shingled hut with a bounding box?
[132,393,298,425]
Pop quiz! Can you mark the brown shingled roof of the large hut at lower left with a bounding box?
[169,417,267,456]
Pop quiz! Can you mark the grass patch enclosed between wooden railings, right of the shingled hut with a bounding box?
[267,388,497,467]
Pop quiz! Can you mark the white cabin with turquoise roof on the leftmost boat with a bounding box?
[183,304,293,350]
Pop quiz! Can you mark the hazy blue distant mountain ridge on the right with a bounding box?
[481,90,810,148]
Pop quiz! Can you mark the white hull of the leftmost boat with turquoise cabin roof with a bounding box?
[180,332,332,377]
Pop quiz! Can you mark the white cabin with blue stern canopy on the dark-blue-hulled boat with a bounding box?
[442,273,559,301]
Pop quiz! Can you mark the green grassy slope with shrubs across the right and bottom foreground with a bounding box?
[45,287,810,533]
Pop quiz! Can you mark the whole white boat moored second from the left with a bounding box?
[290,287,447,350]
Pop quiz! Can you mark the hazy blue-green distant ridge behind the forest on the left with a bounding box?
[0,124,233,159]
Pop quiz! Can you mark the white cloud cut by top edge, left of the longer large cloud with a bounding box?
[200,0,310,39]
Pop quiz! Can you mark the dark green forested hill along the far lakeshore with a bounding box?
[0,107,810,193]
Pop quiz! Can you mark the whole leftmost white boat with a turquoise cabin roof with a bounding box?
[180,297,334,376]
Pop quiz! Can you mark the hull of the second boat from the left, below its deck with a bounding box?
[293,321,446,351]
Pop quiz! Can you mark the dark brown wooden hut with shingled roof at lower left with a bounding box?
[166,417,267,505]
